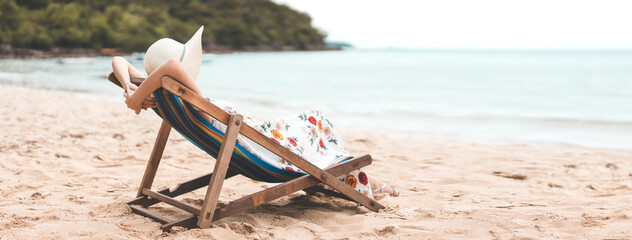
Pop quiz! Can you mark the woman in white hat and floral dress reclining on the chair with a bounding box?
[112,27,399,197]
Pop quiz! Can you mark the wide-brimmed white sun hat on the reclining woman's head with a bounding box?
[145,26,204,79]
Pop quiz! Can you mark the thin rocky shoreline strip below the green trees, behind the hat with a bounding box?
[0,45,342,59]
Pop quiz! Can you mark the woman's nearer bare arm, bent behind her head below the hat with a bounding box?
[123,59,202,114]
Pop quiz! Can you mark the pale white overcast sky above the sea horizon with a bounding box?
[273,0,632,49]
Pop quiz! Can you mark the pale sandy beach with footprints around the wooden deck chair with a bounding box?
[0,85,632,239]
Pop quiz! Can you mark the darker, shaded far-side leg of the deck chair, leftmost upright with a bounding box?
[136,120,171,197]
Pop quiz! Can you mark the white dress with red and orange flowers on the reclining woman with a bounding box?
[207,98,373,198]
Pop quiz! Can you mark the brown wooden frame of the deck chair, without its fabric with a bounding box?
[108,73,384,231]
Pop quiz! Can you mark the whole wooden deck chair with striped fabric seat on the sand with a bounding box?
[108,73,384,231]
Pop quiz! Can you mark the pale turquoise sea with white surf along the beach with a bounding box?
[0,50,632,148]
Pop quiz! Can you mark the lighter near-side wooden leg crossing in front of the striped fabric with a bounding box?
[197,114,243,228]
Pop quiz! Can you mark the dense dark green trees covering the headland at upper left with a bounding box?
[0,0,325,51]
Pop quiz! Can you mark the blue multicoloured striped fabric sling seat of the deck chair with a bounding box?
[154,88,304,182]
